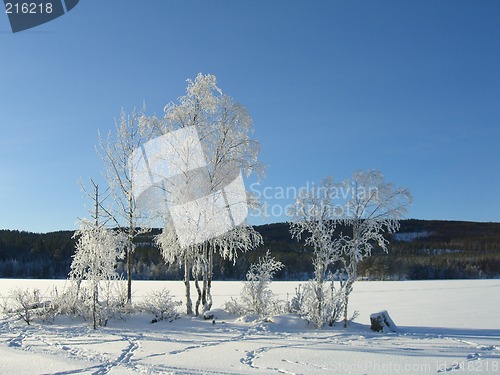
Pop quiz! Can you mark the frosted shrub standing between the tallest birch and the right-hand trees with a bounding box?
[225,251,283,316]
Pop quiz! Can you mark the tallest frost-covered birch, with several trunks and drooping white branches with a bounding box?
[146,73,263,311]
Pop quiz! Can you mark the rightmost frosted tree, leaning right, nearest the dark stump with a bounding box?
[334,169,413,325]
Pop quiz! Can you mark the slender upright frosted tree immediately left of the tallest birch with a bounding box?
[98,108,149,303]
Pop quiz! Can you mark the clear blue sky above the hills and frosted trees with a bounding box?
[0,0,500,232]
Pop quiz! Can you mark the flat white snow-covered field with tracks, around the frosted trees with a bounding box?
[0,279,500,374]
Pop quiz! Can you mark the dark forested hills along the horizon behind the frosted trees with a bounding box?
[0,220,500,280]
